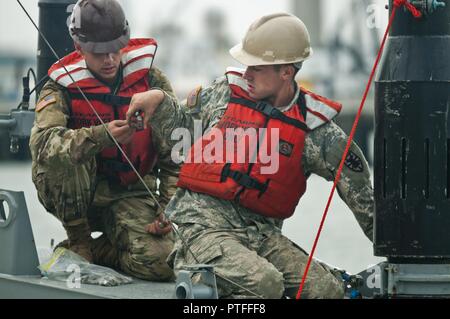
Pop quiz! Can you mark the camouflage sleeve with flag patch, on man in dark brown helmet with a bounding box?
[30,80,114,165]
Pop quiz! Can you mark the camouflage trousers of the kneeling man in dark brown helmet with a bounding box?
[33,159,174,281]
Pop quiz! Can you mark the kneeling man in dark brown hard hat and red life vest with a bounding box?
[30,0,178,281]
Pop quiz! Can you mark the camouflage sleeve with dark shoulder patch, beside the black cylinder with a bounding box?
[302,122,374,241]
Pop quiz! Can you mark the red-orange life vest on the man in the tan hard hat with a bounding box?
[178,70,341,219]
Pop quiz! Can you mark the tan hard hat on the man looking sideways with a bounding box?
[230,13,313,66]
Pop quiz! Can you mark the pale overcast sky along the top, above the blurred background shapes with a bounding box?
[0,0,387,55]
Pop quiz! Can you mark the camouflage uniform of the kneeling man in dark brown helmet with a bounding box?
[30,68,178,281]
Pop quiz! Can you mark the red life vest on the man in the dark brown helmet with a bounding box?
[48,39,157,186]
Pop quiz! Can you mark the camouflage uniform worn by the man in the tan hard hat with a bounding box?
[151,78,374,298]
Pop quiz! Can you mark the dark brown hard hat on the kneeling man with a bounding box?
[69,0,130,53]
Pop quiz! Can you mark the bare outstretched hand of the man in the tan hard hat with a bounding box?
[127,90,164,128]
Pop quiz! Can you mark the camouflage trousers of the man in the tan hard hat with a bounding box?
[174,227,344,299]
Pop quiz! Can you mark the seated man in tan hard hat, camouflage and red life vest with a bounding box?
[128,13,374,298]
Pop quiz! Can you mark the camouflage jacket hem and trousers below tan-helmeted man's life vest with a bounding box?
[166,189,344,299]
